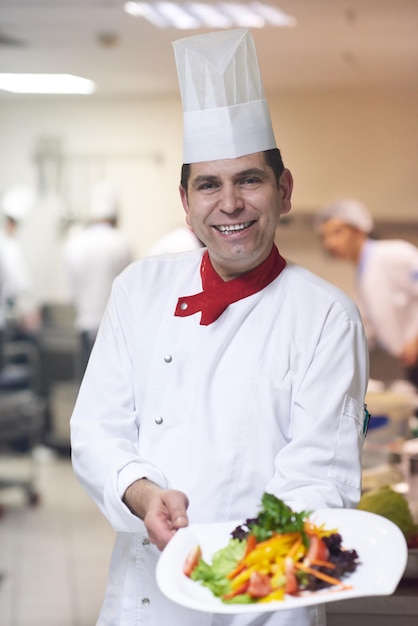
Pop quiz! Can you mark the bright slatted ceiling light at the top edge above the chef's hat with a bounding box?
[125,0,296,30]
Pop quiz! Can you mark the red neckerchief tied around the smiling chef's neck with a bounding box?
[174,245,286,326]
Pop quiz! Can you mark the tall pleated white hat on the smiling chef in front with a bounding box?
[173,28,276,163]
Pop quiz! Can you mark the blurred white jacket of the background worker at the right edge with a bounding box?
[357,239,418,357]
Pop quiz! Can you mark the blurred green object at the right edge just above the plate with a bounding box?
[357,485,418,541]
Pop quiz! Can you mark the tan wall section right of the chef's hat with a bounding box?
[270,92,418,220]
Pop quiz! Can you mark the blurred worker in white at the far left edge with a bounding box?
[0,185,41,336]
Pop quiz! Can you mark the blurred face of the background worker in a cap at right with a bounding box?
[320,218,364,261]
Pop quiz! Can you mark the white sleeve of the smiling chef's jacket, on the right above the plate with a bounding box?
[266,305,369,510]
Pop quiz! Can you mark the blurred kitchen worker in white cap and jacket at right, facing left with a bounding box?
[316,199,418,388]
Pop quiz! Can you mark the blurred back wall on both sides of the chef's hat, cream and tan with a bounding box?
[0,92,418,301]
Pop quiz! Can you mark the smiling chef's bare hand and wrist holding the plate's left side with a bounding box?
[123,478,189,550]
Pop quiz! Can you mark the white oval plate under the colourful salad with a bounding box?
[156,509,408,614]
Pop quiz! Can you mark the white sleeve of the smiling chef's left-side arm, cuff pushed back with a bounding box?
[70,279,167,532]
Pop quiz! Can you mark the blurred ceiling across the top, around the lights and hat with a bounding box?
[0,0,418,98]
